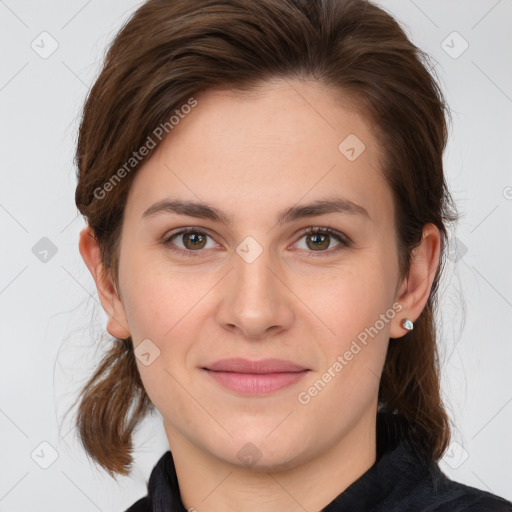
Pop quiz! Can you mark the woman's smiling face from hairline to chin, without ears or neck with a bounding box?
[111,81,404,468]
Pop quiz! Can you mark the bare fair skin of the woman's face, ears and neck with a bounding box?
[79,80,440,512]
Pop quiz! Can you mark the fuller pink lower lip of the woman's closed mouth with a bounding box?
[206,370,308,395]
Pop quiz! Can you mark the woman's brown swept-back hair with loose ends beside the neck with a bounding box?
[71,0,456,475]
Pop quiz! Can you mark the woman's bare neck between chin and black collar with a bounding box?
[165,408,376,512]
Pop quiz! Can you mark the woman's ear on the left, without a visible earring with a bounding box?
[78,226,130,339]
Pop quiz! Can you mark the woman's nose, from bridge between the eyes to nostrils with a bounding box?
[217,247,294,340]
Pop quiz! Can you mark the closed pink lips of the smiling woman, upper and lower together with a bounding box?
[203,358,309,394]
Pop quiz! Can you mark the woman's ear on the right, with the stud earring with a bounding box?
[389,224,441,338]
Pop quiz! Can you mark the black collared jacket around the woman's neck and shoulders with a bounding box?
[126,412,512,512]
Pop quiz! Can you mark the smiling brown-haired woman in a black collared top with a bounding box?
[72,0,512,512]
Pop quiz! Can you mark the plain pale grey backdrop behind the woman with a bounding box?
[0,0,512,512]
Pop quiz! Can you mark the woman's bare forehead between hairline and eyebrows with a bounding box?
[123,80,391,224]
